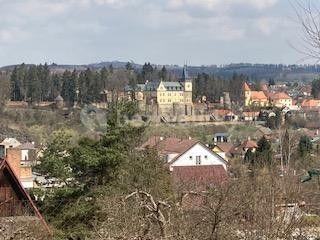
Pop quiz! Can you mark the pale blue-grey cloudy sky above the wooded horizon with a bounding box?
[0,0,312,66]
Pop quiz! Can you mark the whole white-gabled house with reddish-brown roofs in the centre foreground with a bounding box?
[139,136,228,187]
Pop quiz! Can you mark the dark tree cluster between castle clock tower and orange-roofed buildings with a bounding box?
[193,73,248,102]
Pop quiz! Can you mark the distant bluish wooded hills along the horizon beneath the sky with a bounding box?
[0,61,320,81]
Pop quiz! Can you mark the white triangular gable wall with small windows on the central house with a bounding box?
[170,143,227,171]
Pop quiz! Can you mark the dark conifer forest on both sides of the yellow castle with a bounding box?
[1,63,248,106]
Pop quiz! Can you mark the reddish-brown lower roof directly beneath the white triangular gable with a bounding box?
[172,165,228,186]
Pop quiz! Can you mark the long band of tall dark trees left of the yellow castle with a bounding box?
[10,63,178,104]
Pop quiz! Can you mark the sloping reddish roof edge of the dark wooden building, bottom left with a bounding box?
[0,158,51,233]
